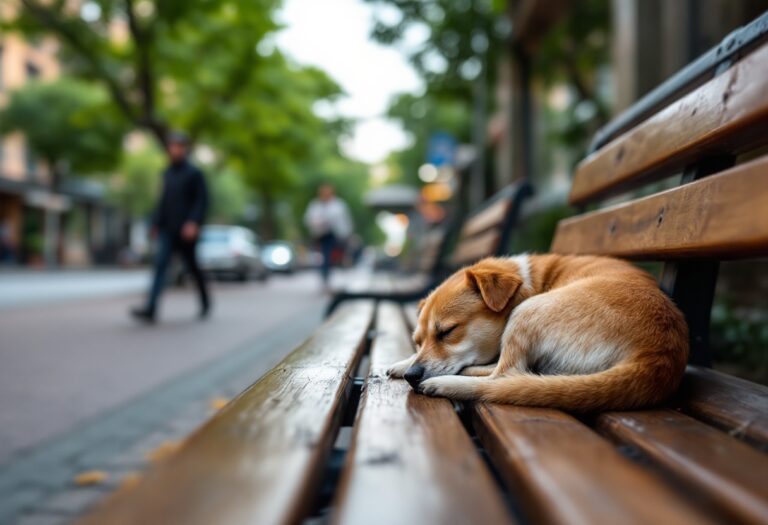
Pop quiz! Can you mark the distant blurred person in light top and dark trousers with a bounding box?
[304,184,352,289]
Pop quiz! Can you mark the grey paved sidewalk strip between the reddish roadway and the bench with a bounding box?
[0,308,320,525]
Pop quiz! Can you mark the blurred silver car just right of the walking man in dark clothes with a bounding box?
[197,225,268,281]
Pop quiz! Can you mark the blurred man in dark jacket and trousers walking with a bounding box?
[131,133,211,323]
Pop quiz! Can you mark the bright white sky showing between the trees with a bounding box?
[277,0,425,163]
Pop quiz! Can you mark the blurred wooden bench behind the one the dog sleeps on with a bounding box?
[326,181,532,315]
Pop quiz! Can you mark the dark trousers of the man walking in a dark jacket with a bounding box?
[147,232,209,314]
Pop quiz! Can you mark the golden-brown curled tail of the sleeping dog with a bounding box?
[468,354,685,412]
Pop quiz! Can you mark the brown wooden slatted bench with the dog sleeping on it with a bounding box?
[79,14,768,525]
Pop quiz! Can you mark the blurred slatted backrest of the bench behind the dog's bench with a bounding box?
[449,181,533,268]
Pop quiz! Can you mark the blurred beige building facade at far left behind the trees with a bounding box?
[0,9,121,266]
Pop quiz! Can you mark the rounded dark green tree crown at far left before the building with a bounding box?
[0,78,126,180]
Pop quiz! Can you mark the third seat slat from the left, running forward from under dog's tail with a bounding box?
[474,404,709,524]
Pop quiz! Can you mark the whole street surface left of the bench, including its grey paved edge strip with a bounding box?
[0,270,327,523]
